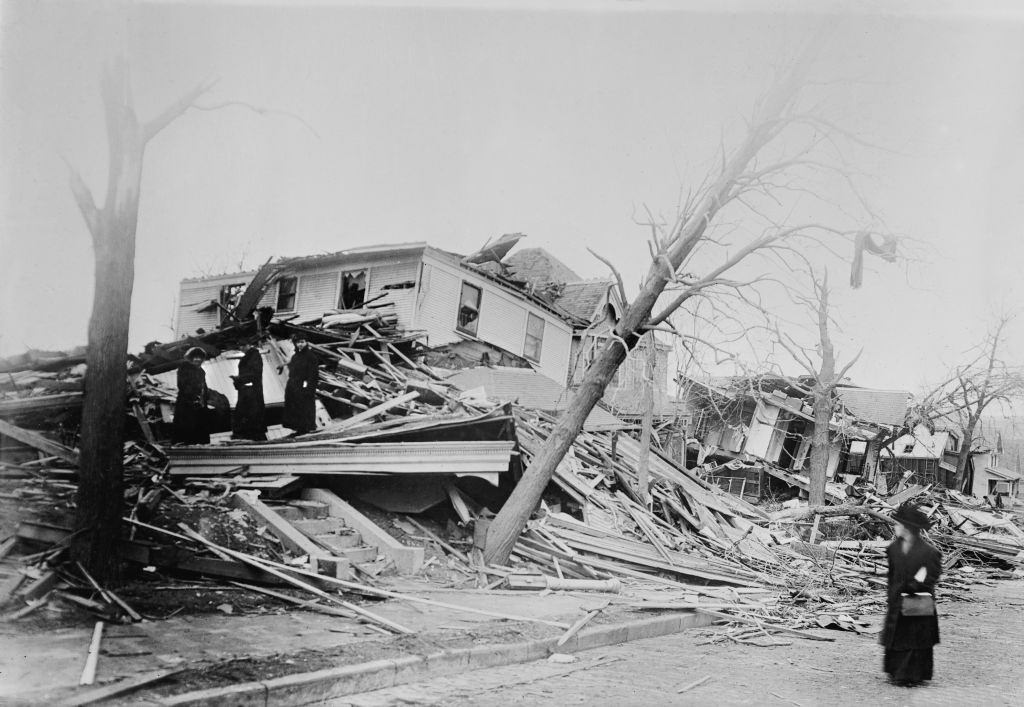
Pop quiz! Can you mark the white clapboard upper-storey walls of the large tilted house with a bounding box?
[175,236,574,380]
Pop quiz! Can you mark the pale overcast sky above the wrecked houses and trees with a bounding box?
[0,1,1024,390]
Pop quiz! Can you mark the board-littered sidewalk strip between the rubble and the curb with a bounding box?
[0,586,710,705]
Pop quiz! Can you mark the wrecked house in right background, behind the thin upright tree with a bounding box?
[687,376,909,499]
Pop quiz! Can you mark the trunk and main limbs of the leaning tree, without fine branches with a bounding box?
[484,55,804,564]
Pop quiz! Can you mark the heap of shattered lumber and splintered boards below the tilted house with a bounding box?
[0,311,1024,644]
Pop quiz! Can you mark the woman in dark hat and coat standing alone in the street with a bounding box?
[881,503,942,687]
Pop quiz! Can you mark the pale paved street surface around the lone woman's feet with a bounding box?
[332,579,1024,707]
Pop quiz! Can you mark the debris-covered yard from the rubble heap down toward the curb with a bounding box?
[0,306,1024,699]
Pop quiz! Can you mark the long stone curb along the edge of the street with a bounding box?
[157,613,715,707]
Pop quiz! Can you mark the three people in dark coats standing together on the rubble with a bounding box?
[172,335,318,445]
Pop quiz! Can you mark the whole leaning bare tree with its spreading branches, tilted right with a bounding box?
[484,51,892,563]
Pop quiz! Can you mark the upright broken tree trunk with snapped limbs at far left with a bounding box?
[71,59,211,582]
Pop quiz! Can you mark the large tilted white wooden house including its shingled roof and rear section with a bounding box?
[176,234,682,434]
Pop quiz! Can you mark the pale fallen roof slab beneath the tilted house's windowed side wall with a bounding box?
[438,366,628,429]
